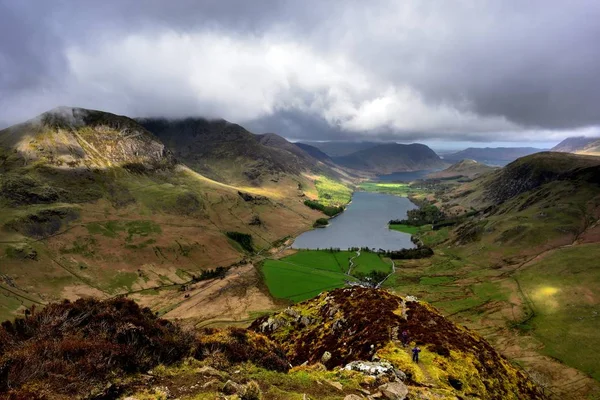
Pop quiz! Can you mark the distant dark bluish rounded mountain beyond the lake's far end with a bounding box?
[333,143,446,175]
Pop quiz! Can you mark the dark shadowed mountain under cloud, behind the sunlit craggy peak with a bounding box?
[138,118,337,186]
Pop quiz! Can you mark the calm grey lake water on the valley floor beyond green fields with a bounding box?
[292,192,417,250]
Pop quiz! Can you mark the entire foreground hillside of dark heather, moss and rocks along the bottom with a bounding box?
[0,288,545,400]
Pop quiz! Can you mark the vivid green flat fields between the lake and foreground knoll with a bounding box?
[262,250,391,302]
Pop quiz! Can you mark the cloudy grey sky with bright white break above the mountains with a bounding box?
[0,0,600,148]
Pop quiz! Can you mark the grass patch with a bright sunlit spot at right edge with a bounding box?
[516,243,600,380]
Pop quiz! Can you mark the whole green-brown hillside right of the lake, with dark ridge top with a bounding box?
[386,152,600,399]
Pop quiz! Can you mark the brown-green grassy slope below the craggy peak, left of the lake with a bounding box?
[0,163,320,319]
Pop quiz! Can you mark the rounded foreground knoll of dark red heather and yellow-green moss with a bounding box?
[251,288,544,399]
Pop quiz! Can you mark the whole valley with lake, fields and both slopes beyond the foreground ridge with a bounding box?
[0,109,600,399]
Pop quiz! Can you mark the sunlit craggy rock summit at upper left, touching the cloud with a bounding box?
[0,107,174,169]
